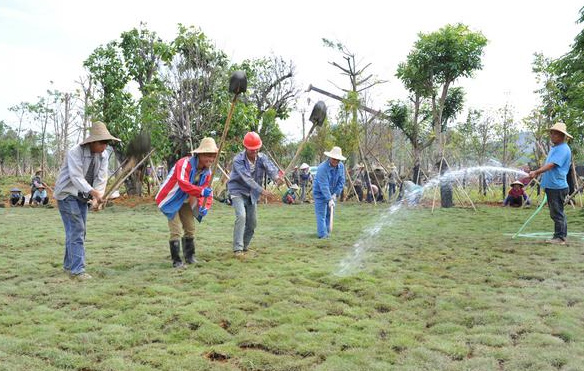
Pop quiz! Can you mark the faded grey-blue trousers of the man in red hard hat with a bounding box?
[231,196,257,251]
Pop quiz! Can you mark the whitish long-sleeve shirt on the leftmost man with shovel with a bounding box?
[53,144,109,200]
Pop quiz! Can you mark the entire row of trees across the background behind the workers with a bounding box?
[0,8,582,201]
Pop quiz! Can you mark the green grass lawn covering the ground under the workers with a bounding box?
[0,204,584,370]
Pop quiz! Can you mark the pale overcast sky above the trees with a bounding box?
[0,0,583,138]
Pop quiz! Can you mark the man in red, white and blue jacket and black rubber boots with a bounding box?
[156,138,219,268]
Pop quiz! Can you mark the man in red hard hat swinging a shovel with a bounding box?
[227,131,284,259]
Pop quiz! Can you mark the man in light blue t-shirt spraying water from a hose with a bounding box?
[529,122,572,245]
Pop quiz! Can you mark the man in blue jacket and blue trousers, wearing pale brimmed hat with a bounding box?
[312,147,346,238]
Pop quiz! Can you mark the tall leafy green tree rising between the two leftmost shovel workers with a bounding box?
[84,24,172,194]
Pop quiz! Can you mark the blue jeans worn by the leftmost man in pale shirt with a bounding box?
[57,196,88,275]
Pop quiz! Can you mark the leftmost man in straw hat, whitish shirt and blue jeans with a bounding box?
[53,121,120,280]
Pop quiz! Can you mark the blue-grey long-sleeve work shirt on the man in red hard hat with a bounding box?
[227,150,278,204]
